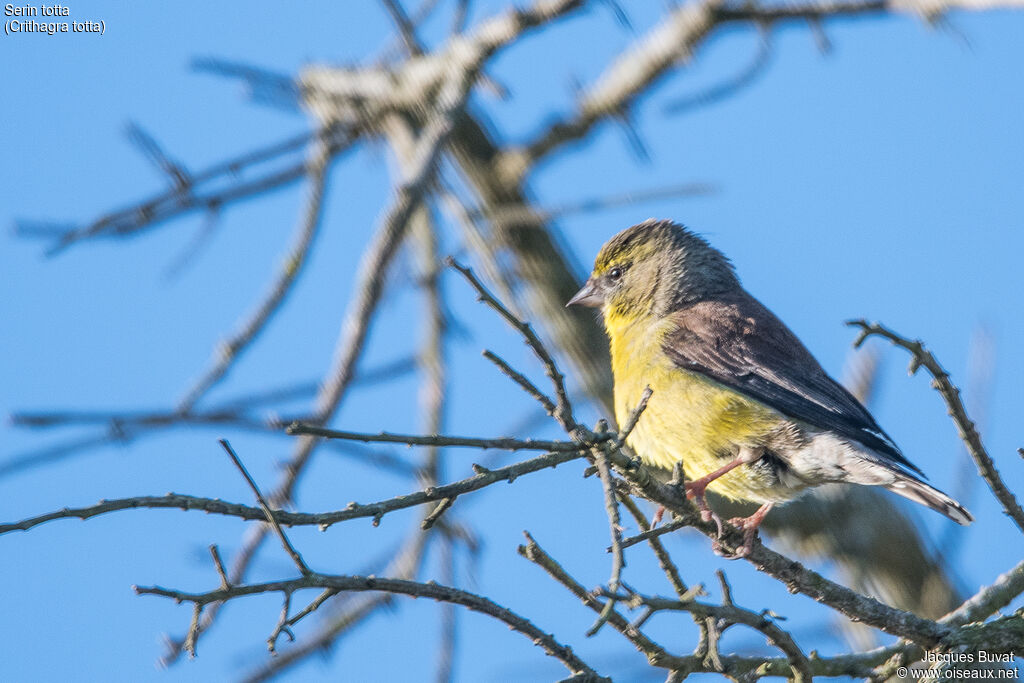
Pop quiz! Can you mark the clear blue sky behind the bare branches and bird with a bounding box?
[0,1,1024,681]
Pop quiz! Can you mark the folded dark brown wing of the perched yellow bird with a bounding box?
[665,291,924,475]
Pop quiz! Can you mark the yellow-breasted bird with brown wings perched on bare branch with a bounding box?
[566,219,974,556]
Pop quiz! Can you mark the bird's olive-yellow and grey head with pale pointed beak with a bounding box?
[566,219,739,318]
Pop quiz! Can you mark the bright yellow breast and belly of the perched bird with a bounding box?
[605,315,783,502]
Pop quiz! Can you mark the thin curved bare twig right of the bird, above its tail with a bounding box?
[847,321,1024,532]
